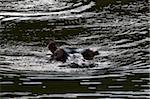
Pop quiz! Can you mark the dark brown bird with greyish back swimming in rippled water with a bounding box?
[48,40,99,62]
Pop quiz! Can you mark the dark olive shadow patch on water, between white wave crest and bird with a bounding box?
[1,19,85,42]
